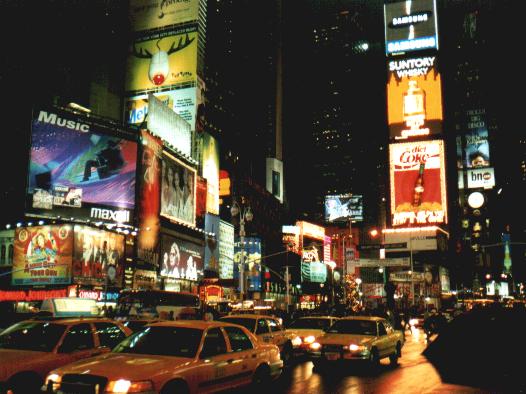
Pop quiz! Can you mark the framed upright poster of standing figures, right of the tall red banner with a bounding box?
[161,152,196,227]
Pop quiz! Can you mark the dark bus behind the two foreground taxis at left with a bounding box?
[115,290,201,320]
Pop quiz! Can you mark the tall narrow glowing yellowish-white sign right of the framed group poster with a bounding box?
[202,133,219,215]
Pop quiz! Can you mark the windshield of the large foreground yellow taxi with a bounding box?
[113,326,203,358]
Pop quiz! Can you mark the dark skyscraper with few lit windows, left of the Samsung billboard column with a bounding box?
[285,1,387,228]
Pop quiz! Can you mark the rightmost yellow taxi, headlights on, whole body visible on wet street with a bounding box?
[309,316,404,367]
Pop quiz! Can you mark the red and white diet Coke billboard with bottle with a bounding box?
[389,140,447,226]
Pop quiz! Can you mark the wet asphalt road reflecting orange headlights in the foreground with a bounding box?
[235,331,501,394]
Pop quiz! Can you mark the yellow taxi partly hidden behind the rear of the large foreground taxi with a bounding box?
[219,314,294,365]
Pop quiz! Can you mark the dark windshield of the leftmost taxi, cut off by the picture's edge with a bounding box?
[0,322,66,352]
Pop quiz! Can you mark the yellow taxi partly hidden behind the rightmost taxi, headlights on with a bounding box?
[285,316,338,355]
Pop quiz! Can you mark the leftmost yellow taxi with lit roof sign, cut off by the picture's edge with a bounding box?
[0,299,132,394]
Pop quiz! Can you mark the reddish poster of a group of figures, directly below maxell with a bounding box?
[73,225,124,287]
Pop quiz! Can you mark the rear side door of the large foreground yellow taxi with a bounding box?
[223,326,258,384]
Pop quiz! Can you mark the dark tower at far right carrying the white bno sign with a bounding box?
[442,1,526,295]
